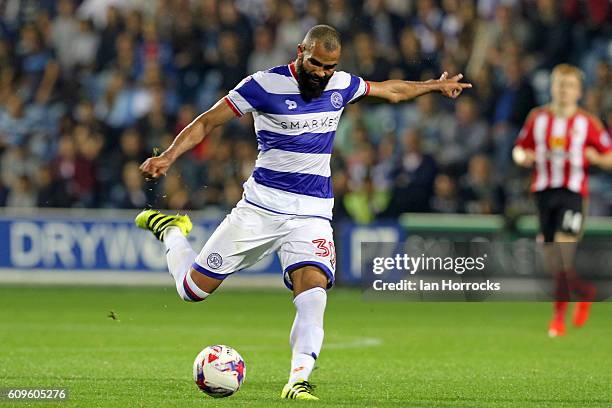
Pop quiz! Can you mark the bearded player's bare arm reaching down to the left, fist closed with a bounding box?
[140,99,235,178]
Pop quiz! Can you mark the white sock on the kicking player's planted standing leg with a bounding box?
[289,288,327,384]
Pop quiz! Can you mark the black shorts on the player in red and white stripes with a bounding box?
[535,188,584,242]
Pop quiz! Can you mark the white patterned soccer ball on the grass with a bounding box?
[193,345,246,398]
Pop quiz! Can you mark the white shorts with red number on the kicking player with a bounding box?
[193,200,336,289]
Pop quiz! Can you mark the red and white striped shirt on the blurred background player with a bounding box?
[516,106,612,196]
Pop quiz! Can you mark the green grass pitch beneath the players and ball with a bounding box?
[0,286,612,408]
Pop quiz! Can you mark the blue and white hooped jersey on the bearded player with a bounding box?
[225,63,370,220]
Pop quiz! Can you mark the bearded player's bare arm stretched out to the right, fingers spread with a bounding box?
[368,72,472,103]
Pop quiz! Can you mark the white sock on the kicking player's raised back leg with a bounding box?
[164,227,208,302]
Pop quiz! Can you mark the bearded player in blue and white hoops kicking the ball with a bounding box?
[136,25,471,400]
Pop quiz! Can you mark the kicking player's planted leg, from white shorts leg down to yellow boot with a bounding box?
[279,219,335,399]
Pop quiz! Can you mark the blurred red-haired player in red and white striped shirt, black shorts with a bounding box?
[512,64,612,337]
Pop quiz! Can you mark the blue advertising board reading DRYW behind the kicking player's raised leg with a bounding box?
[0,211,281,274]
